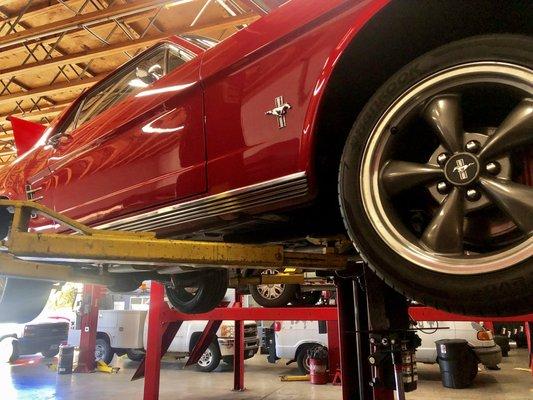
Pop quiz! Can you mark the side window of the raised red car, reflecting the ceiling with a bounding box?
[61,45,194,134]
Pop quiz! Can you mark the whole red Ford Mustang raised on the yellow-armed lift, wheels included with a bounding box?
[0,0,533,314]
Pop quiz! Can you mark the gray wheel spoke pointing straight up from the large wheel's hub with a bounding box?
[424,94,463,152]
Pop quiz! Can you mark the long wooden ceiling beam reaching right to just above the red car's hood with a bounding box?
[0,13,259,79]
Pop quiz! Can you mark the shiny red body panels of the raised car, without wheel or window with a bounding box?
[0,0,388,236]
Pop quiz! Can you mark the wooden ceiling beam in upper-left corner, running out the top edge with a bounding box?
[0,0,196,48]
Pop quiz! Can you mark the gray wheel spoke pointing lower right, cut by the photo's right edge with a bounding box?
[479,177,533,234]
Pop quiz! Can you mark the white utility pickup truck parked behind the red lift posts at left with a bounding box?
[69,310,259,372]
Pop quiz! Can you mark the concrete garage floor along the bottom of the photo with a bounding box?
[0,349,533,400]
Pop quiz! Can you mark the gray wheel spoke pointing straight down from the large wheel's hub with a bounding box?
[422,188,464,254]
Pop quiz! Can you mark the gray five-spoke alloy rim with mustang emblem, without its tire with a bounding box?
[361,62,533,274]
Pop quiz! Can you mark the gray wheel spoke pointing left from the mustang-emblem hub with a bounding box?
[381,161,444,196]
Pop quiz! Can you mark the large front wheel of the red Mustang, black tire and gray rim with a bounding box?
[339,35,533,315]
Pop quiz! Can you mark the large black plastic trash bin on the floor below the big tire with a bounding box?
[435,339,478,389]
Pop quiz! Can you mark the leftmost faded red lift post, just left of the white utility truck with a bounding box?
[74,285,105,373]
